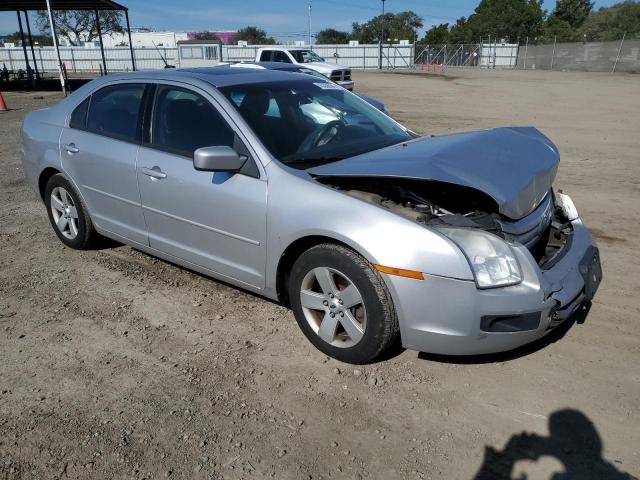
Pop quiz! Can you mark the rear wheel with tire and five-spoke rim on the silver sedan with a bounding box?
[44,174,98,250]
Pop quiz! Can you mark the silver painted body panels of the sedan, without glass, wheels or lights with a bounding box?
[22,68,593,354]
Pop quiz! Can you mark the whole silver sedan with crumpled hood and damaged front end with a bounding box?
[22,67,602,363]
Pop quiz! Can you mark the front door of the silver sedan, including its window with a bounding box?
[138,84,267,288]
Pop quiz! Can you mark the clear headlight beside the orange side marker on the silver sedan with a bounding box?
[438,228,522,288]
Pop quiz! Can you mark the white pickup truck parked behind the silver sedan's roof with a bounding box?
[256,47,353,90]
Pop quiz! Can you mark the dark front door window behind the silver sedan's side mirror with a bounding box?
[151,86,235,157]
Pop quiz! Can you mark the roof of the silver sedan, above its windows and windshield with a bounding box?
[92,65,317,88]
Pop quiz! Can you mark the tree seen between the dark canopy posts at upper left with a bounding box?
[36,10,124,45]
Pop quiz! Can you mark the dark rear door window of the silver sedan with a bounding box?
[87,83,144,142]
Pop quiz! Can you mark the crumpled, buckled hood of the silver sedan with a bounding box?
[308,127,560,219]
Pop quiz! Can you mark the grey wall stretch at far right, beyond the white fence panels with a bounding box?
[517,38,640,73]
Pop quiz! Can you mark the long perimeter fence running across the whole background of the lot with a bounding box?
[0,36,640,74]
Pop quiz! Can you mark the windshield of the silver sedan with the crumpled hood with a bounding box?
[220,78,412,169]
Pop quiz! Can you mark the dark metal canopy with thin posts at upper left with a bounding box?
[0,0,136,95]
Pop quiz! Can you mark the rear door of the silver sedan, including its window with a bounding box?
[60,83,147,245]
